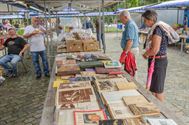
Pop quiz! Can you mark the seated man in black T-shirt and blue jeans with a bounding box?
[0,27,29,77]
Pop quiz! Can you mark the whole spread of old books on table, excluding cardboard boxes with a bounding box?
[53,53,179,125]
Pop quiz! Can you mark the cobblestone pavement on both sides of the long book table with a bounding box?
[0,33,189,125]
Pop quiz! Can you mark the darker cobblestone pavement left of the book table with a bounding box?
[0,59,49,125]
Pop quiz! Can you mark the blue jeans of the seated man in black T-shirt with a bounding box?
[0,54,22,74]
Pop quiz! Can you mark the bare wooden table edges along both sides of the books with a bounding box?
[40,59,184,125]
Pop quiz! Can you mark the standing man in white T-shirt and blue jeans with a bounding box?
[24,17,49,79]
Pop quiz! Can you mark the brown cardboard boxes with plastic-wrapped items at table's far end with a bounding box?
[57,29,99,53]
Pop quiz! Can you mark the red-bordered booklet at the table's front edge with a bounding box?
[74,110,107,125]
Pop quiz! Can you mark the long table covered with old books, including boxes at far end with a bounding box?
[40,30,183,125]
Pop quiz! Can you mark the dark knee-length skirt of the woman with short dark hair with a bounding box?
[148,57,168,93]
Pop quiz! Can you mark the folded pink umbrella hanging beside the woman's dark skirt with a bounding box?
[146,57,155,90]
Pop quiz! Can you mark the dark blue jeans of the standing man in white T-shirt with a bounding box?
[31,50,49,75]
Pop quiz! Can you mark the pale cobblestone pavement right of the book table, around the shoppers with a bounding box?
[106,34,189,125]
